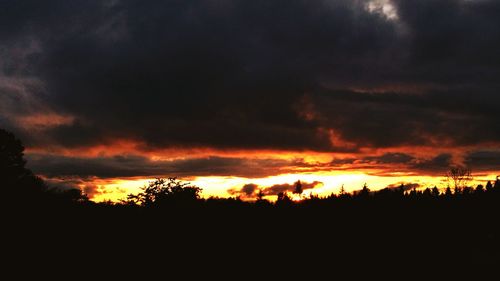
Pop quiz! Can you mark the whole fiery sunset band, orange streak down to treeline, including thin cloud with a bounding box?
[28,142,497,202]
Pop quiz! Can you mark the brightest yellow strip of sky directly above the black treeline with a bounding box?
[71,172,497,202]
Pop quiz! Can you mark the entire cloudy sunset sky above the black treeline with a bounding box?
[0,0,500,201]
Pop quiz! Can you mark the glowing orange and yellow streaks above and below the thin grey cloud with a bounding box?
[27,137,498,201]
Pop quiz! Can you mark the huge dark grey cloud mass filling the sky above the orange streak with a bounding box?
[0,0,500,153]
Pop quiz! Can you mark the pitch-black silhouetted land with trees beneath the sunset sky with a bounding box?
[0,130,500,274]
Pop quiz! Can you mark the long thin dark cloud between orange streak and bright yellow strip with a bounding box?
[27,151,500,179]
